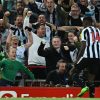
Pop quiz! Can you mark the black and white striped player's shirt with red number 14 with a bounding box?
[81,26,100,58]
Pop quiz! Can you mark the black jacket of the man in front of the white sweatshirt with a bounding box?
[38,44,66,73]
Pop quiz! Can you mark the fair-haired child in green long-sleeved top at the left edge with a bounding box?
[0,47,35,86]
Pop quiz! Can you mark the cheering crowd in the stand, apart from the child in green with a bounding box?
[0,0,100,86]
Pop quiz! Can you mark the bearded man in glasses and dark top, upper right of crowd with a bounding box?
[68,3,82,26]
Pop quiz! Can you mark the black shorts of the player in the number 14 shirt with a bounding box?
[76,58,100,77]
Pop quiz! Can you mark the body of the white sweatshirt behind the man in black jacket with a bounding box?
[28,33,49,65]
